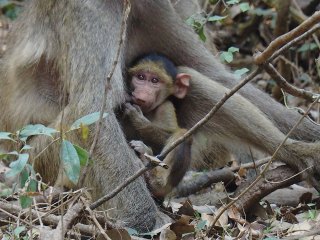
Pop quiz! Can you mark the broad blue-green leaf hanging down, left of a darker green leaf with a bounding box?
[60,140,80,184]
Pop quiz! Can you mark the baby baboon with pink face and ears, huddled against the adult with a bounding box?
[123,60,191,199]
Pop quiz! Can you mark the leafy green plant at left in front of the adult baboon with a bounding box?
[0,112,108,208]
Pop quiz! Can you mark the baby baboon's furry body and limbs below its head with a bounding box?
[123,100,192,199]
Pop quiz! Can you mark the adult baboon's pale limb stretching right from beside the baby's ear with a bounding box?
[177,67,320,186]
